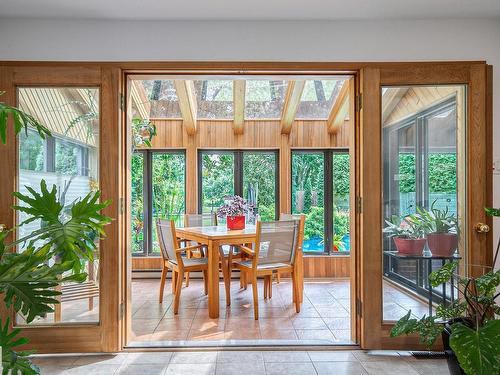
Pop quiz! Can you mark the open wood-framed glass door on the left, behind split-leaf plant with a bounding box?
[0,67,119,352]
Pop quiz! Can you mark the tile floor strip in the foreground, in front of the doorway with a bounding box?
[33,351,449,375]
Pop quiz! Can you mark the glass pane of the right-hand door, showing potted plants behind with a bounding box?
[382,86,465,320]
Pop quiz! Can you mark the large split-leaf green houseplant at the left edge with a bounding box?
[0,93,111,375]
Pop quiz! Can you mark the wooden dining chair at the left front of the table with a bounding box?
[156,219,208,314]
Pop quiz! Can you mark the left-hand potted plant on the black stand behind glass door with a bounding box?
[384,215,426,255]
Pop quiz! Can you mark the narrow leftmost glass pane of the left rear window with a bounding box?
[131,152,145,254]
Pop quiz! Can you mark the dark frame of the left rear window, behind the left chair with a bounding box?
[131,149,187,258]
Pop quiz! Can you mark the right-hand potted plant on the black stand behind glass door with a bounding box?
[417,200,458,257]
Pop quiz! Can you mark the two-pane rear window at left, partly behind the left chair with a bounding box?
[131,150,186,256]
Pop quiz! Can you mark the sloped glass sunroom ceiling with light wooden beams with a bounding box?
[130,76,349,132]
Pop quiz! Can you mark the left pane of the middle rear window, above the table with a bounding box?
[201,152,234,219]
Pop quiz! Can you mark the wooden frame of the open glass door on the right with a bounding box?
[356,62,493,349]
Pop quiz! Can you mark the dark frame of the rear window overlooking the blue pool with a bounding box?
[290,147,353,256]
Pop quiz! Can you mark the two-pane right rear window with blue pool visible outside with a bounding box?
[292,150,350,254]
